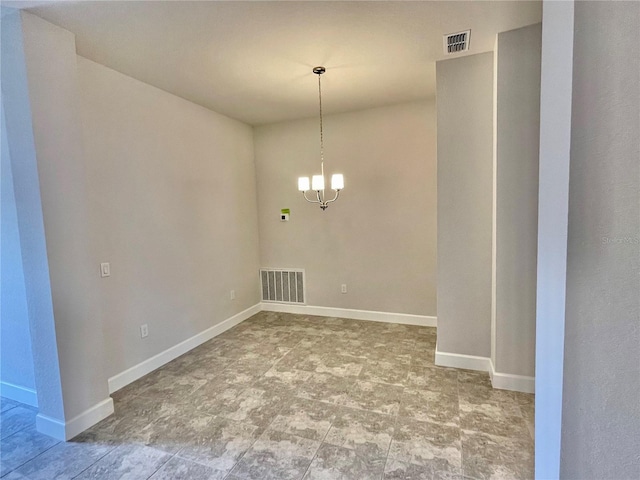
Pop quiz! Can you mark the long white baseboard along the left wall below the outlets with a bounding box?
[109,303,260,393]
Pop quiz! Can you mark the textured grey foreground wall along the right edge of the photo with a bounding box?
[564,2,640,479]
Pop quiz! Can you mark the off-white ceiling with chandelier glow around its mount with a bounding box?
[16,1,542,125]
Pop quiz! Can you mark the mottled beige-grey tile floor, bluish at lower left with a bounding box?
[0,312,533,480]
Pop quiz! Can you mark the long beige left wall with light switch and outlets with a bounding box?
[78,57,259,383]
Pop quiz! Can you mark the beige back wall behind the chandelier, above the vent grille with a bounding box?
[255,102,436,316]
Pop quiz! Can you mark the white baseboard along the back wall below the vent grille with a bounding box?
[260,302,437,327]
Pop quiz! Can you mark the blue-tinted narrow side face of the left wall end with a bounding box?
[0,8,64,423]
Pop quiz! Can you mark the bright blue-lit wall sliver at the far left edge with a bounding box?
[0,99,38,407]
